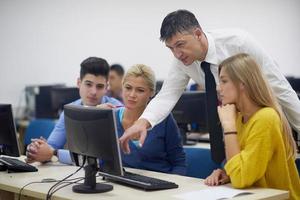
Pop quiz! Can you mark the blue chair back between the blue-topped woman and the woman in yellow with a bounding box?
[184,147,220,179]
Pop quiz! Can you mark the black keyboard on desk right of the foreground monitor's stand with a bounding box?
[99,172,178,191]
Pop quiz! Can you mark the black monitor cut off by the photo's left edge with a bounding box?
[0,104,20,157]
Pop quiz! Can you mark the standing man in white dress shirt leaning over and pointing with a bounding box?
[120,10,300,153]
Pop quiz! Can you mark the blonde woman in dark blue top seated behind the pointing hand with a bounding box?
[116,64,186,175]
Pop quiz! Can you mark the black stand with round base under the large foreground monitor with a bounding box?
[72,158,113,194]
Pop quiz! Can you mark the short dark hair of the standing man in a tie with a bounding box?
[160,10,201,42]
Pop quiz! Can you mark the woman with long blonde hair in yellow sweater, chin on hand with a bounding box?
[205,54,300,199]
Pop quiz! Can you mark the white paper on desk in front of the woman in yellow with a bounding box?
[174,186,252,200]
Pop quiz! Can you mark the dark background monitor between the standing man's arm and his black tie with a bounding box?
[172,91,208,145]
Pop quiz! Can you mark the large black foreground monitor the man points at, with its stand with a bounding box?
[64,104,123,192]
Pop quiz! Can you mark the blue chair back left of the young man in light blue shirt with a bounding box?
[24,119,55,146]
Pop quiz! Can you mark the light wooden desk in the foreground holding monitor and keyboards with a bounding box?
[0,163,288,200]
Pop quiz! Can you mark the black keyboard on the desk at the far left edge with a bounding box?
[0,157,38,172]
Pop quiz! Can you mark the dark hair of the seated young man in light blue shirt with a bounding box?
[80,57,109,79]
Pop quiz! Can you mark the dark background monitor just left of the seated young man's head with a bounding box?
[51,87,80,118]
